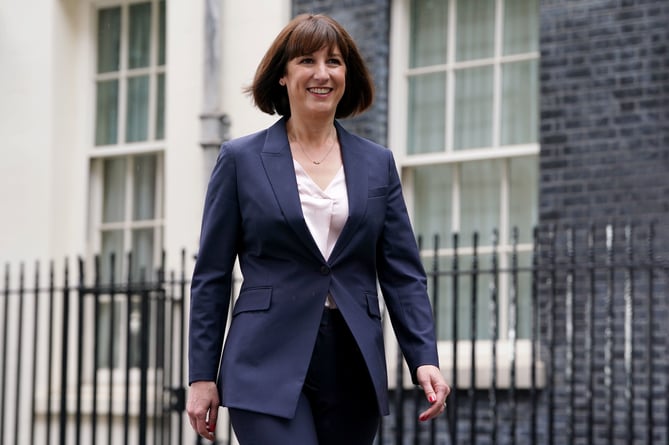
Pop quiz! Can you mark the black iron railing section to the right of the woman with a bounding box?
[379,225,669,445]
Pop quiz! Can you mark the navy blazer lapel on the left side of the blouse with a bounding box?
[261,118,324,261]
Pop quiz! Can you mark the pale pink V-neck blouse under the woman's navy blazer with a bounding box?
[293,160,348,307]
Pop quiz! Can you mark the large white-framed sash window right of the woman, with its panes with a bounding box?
[390,0,539,340]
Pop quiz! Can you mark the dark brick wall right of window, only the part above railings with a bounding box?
[540,0,669,231]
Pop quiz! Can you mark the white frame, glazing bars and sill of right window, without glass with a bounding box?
[388,0,545,388]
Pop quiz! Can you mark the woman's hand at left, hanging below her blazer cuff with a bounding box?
[186,381,219,441]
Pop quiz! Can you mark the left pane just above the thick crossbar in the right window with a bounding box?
[407,73,446,154]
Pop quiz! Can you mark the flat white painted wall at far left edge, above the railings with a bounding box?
[0,0,55,263]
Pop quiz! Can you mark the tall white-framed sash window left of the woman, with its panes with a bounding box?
[89,0,166,369]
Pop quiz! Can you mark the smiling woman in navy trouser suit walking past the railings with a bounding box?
[187,15,450,445]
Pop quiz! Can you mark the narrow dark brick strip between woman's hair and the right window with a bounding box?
[293,0,390,145]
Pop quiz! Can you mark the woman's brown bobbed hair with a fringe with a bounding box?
[245,14,374,118]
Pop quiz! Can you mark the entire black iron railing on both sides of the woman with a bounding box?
[0,225,669,445]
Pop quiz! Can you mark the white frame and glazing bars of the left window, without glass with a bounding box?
[87,0,167,382]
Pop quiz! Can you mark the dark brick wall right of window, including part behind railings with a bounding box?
[539,0,669,443]
